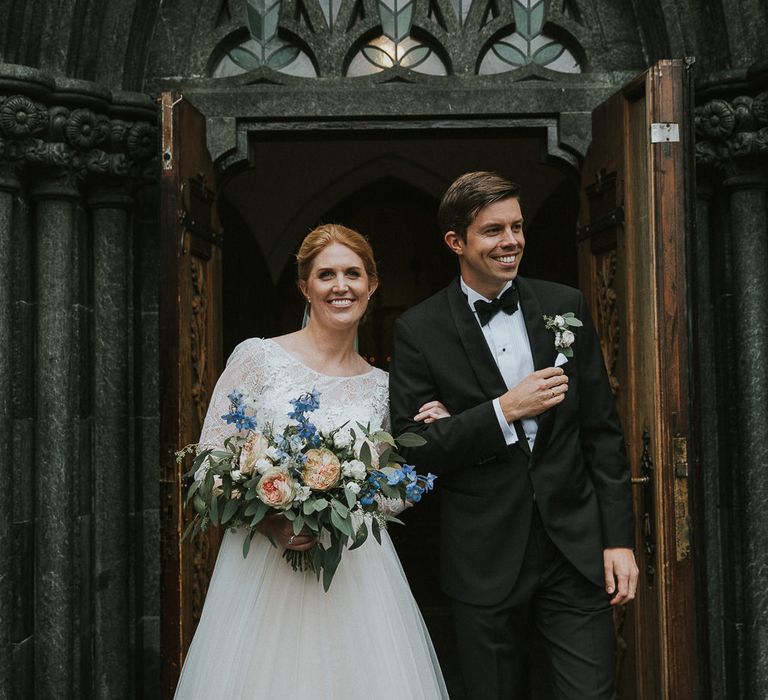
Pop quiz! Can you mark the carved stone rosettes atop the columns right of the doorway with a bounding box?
[695,91,768,170]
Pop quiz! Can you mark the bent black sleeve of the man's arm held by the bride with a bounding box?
[389,319,506,474]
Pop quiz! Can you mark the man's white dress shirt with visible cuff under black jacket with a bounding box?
[461,278,538,449]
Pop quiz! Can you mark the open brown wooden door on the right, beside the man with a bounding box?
[579,61,697,700]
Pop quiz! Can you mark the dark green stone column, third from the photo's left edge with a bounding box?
[89,186,133,700]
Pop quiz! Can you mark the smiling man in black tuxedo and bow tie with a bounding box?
[390,172,637,700]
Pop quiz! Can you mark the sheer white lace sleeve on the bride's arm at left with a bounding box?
[198,338,261,450]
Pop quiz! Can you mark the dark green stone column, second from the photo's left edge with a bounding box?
[32,174,79,700]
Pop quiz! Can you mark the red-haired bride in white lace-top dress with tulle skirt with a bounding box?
[175,225,448,700]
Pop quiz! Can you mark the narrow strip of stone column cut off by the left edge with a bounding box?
[0,160,19,698]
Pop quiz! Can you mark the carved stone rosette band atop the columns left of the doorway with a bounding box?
[0,94,159,186]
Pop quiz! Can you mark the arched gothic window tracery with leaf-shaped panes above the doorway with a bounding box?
[210,0,584,80]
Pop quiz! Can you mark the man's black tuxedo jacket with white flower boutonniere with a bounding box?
[390,277,634,605]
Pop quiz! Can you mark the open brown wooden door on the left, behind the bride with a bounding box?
[160,93,223,698]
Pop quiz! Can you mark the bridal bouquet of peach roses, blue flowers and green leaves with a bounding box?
[176,390,436,590]
